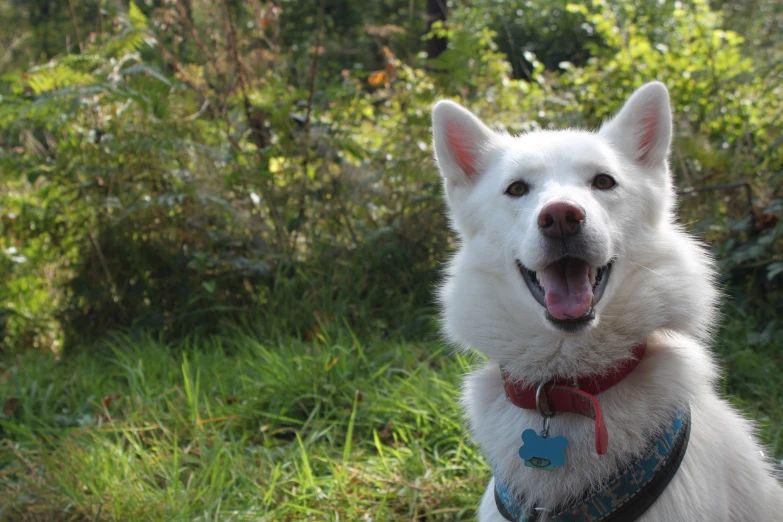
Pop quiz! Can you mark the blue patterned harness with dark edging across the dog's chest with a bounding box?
[495,407,691,522]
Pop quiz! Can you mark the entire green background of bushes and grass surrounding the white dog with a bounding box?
[0,0,783,521]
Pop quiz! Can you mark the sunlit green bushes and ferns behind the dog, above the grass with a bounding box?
[0,0,783,350]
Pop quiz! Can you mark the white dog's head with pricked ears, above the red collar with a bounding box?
[433,82,715,373]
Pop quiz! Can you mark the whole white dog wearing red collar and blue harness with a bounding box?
[433,82,783,522]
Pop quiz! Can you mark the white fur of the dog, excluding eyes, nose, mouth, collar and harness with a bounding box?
[433,82,783,522]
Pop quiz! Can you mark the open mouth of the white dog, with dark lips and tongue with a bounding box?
[517,257,612,331]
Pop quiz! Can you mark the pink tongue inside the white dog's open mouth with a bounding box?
[539,258,593,319]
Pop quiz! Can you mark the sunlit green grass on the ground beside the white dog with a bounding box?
[0,310,783,521]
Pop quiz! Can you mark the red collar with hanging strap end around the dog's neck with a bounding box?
[500,341,647,455]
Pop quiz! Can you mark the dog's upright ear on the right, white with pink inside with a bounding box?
[598,82,672,167]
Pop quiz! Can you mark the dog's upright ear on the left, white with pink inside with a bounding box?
[432,100,496,185]
